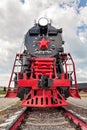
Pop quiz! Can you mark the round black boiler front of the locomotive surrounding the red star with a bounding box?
[25,24,64,57]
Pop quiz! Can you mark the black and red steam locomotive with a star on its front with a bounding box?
[6,17,80,107]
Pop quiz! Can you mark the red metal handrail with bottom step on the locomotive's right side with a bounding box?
[62,53,80,98]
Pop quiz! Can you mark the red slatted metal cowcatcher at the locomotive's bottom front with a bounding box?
[21,89,68,108]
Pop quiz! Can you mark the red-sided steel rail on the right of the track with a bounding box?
[65,110,87,130]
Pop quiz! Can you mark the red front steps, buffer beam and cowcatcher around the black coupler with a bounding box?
[18,58,70,107]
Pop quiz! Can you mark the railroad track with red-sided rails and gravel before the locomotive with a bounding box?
[0,107,87,130]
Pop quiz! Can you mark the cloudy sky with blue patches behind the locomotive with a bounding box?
[0,0,87,86]
